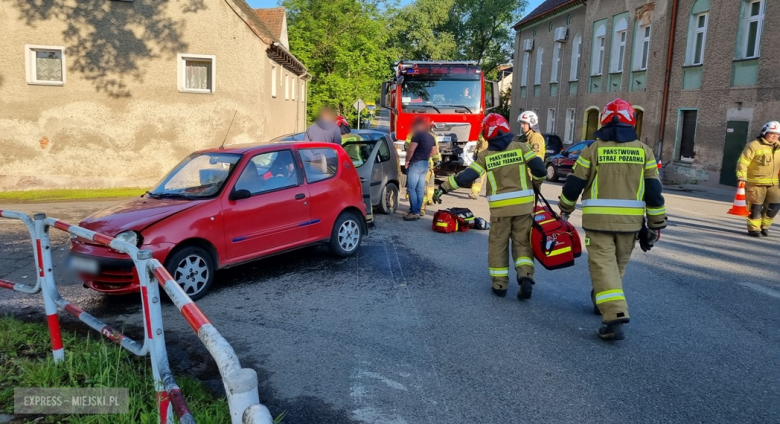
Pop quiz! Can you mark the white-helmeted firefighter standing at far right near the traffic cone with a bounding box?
[737,121,780,237]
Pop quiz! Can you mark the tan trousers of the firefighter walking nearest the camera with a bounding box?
[585,231,636,322]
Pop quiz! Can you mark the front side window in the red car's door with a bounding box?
[236,150,298,195]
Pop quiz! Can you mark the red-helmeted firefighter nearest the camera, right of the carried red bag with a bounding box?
[558,99,666,340]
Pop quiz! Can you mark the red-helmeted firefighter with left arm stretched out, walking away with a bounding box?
[433,113,546,300]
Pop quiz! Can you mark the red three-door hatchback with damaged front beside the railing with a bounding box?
[69,142,368,299]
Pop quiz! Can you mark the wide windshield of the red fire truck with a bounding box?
[401,78,482,113]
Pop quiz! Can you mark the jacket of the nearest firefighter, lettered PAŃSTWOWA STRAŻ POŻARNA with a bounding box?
[560,139,666,233]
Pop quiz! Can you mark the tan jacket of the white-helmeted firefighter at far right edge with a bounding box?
[737,137,780,186]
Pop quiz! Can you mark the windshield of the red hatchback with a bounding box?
[148,153,241,199]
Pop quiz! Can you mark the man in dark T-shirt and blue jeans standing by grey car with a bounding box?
[404,118,436,221]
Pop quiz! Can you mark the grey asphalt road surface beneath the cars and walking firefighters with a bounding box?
[0,184,780,424]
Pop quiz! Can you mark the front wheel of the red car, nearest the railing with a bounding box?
[165,246,215,300]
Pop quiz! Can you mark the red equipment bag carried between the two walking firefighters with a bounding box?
[531,192,582,270]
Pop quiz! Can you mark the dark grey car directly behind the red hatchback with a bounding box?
[272,130,401,214]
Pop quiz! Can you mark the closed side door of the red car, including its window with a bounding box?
[223,149,309,261]
